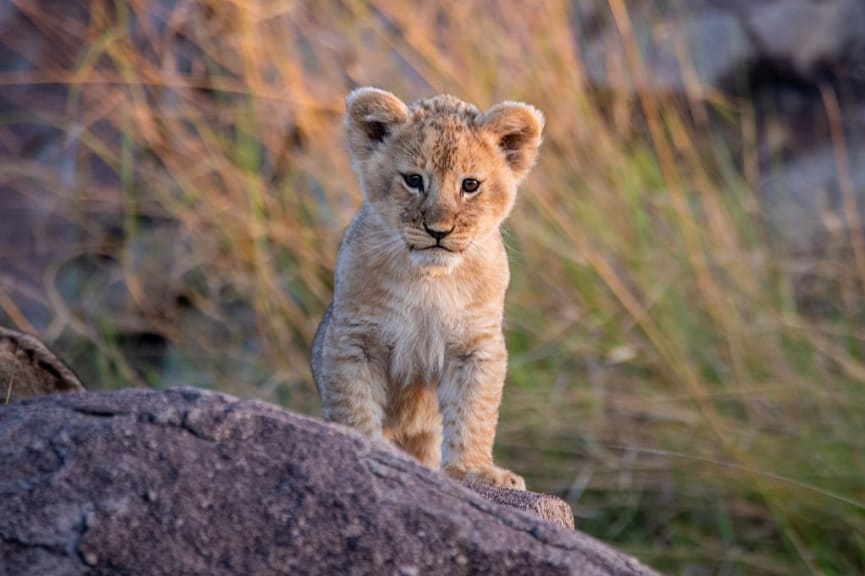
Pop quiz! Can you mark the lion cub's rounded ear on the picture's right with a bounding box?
[479,102,544,180]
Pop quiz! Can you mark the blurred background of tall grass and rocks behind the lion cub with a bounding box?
[0,0,865,575]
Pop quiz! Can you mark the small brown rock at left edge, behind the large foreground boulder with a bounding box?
[0,326,85,404]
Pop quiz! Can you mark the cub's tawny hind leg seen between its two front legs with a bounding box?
[388,384,442,470]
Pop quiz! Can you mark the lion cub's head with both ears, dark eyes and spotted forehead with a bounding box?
[346,88,544,269]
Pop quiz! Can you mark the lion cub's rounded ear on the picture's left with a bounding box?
[345,88,409,161]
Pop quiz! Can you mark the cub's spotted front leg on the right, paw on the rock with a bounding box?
[438,333,526,490]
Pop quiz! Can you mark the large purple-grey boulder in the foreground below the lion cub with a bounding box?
[0,389,652,576]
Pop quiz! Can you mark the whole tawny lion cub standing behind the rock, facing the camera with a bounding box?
[312,88,544,489]
